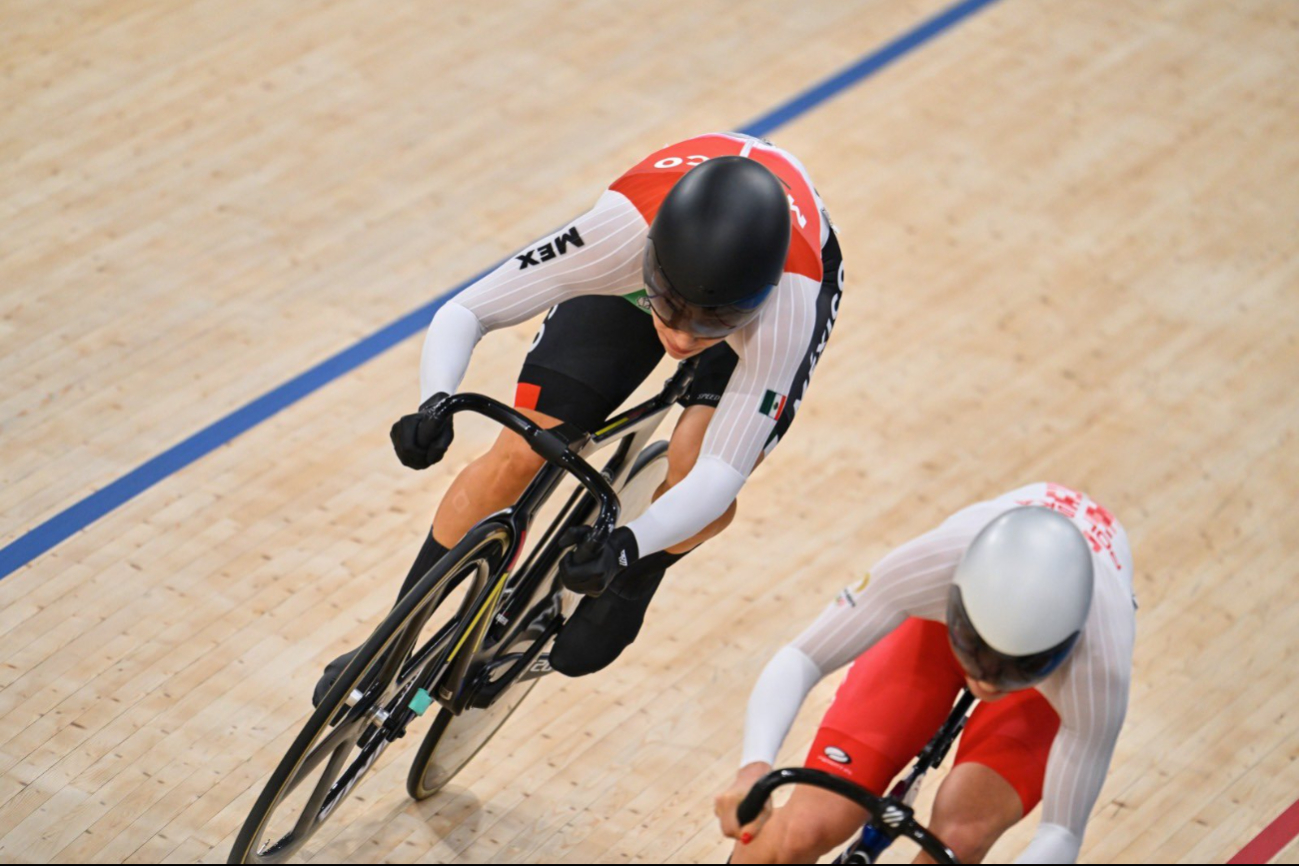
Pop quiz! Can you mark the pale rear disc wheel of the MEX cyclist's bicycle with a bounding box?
[407,441,668,800]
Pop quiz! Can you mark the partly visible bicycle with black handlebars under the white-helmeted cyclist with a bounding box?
[735,689,974,863]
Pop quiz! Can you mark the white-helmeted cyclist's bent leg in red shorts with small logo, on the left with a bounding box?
[735,619,965,863]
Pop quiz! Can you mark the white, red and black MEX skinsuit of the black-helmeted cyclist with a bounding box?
[420,134,843,556]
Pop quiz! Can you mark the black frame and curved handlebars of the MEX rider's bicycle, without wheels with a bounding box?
[407,358,696,714]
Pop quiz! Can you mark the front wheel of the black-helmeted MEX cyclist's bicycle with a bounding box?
[227,525,509,863]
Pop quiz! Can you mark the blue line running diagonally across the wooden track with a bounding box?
[0,0,996,586]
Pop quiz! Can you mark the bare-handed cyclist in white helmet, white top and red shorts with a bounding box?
[716,484,1135,863]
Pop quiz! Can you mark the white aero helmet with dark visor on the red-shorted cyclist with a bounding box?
[947,505,1094,692]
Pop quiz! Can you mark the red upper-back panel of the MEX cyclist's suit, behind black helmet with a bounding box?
[609,132,822,282]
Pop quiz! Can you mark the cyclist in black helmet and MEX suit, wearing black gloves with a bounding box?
[314,134,843,702]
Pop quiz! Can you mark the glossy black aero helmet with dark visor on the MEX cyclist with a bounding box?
[643,156,790,338]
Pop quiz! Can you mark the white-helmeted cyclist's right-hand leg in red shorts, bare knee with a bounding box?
[917,689,1060,863]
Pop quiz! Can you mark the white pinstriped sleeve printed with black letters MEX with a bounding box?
[420,190,648,400]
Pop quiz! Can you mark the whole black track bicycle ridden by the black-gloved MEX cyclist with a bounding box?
[229,360,696,863]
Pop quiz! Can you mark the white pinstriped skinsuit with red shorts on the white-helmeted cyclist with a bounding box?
[743,484,1137,862]
